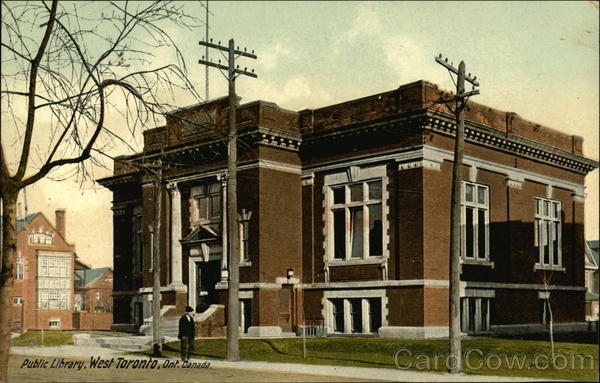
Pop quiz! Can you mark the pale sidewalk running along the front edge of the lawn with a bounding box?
[11,345,541,382]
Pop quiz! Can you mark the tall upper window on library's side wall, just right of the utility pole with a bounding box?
[461,182,490,261]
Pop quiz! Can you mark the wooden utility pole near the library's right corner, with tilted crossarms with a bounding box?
[435,54,479,374]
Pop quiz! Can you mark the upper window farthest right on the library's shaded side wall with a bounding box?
[534,198,562,267]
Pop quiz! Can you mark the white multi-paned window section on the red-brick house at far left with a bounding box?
[37,254,71,310]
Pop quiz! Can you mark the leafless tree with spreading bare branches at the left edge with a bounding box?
[0,0,200,381]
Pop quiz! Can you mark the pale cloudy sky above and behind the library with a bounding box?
[3,1,599,267]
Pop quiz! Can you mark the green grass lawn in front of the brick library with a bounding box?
[138,338,598,381]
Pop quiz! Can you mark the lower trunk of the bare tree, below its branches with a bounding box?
[0,188,19,382]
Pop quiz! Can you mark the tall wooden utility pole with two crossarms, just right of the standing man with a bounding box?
[198,39,258,361]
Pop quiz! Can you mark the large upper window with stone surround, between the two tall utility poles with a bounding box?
[330,180,383,260]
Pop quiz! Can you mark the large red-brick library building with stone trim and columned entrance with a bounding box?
[99,81,598,338]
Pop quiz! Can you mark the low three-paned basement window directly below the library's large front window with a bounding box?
[329,298,382,334]
